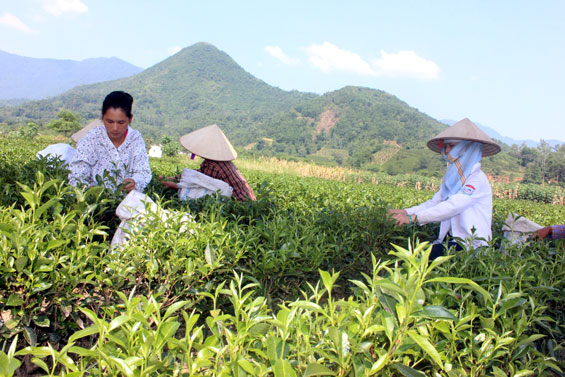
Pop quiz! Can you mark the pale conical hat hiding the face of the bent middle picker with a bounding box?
[180,124,237,161]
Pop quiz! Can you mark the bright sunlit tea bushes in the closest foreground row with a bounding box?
[16,243,560,376]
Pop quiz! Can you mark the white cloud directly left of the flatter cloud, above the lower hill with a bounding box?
[306,42,377,76]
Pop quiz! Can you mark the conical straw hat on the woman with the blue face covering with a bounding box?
[427,118,500,157]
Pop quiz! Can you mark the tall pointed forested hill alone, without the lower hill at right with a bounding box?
[0,43,316,137]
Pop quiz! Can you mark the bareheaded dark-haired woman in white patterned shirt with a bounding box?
[69,91,152,192]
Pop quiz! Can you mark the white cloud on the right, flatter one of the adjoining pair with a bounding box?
[373,50,440,80]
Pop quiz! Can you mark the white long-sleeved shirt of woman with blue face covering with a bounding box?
[406,163,492,247]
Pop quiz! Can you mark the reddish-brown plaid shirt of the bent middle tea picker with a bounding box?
[198,160,257,201]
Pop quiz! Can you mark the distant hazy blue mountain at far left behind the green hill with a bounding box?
[0,51,143,100]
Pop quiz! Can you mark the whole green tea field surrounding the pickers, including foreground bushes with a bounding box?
[0,139,565,377]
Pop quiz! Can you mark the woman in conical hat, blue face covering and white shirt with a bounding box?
[389,118,500,259]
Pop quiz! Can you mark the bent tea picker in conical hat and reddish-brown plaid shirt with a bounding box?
[161,124,257,201]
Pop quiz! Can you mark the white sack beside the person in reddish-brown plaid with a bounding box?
[178,169,233,200]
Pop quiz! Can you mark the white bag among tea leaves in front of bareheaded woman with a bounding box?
[110,190,192,248]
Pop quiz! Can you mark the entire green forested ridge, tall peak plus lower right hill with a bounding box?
[0,43,446,166]
